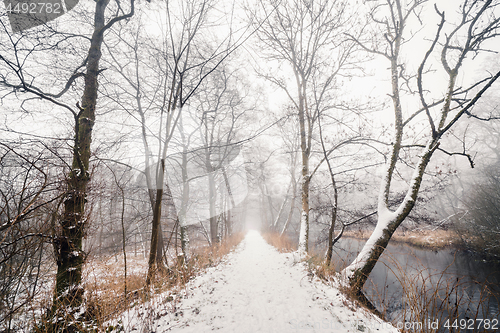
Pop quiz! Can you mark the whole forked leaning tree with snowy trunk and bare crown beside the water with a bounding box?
[343,0,500,299]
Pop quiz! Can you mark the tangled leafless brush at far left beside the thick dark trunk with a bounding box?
[0,140,61,332]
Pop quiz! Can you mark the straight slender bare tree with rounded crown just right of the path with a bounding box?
[252,0,357,253]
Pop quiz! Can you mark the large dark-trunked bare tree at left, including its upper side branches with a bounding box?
[0,0,134,331]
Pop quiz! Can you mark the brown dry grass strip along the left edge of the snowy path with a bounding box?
[30,233,244,333]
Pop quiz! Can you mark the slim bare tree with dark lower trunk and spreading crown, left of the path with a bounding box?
[102,0,244,284]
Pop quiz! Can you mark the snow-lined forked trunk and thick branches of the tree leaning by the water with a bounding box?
[343,0,500,292]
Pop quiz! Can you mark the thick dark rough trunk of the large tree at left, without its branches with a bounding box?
[51,0,109,331]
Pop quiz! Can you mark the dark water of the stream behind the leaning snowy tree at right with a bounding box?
[334,238,500,332]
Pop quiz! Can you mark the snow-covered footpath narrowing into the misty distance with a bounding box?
[110,231,398,333]
